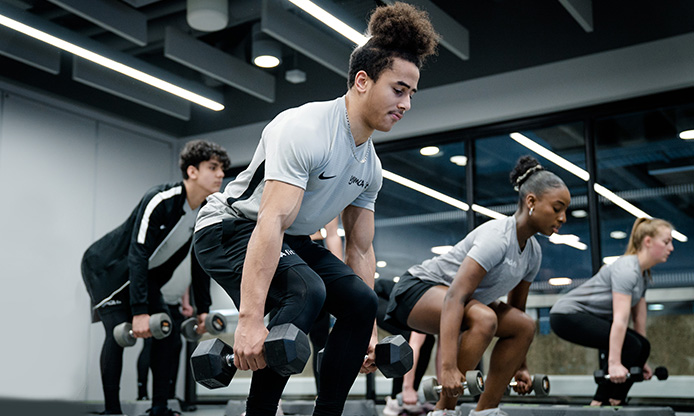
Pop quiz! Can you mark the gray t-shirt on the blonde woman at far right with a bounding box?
[550,255,646,319]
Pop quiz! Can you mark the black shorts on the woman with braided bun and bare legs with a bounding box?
[384,272,441,331]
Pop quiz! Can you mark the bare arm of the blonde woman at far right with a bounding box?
[607,292,631,383]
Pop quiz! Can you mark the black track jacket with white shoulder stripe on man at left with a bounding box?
[82,182,211,315]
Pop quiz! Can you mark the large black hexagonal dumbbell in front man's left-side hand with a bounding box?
[190,323,311,389]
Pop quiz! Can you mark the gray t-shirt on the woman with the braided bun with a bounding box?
[408,215,542,305]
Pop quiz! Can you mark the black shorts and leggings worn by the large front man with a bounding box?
[194,218,378,416]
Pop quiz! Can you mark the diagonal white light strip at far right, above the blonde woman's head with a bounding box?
[510,132,688,243]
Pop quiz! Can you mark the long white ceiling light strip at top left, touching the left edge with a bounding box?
[0,15,224,111]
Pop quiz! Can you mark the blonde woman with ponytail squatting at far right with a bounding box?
[550,218,674,406]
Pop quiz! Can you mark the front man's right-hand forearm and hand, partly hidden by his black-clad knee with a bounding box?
[342,205,378,373]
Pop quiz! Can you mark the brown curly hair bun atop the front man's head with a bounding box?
[369,2,439,61]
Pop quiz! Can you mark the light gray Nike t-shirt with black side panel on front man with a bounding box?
[195,96,383,235]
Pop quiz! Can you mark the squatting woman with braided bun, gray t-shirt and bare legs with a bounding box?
[387,156,571,416]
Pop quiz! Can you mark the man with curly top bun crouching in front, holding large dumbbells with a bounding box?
[195,3,438,416]
